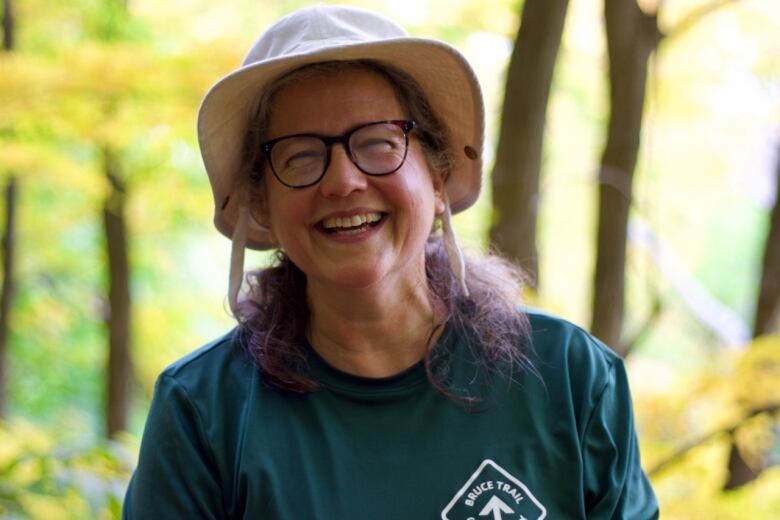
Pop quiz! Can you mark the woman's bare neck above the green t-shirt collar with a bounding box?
[307,268,441,377]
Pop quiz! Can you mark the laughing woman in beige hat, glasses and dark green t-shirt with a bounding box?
[124,5,657,519]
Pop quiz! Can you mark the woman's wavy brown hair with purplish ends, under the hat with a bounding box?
[236,60,533,401]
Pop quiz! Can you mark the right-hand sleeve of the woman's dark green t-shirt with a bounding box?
[583,359,658,520]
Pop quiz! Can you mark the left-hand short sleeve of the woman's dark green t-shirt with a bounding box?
[122,374,225,520]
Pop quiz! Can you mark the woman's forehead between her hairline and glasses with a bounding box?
[267,68,405,138]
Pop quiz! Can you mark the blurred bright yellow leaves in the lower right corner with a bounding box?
[636,335,780,519]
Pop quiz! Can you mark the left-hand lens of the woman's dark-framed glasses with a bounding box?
[271,137,328,186]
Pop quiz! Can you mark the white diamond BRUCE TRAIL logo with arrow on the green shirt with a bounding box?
[441,459,547,520]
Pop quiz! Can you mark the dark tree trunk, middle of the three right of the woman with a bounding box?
[591,0,661,355]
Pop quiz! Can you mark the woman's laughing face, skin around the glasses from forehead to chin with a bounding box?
[264,70,444,288]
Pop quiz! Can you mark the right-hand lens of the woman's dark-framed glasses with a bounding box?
[349,123,406,175]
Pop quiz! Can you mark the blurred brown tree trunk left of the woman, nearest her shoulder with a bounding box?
[103,148,132,438]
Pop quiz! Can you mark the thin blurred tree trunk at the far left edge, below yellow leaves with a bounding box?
[0,176,17,419]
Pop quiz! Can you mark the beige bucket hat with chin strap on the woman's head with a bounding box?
[198,4,485,307]
